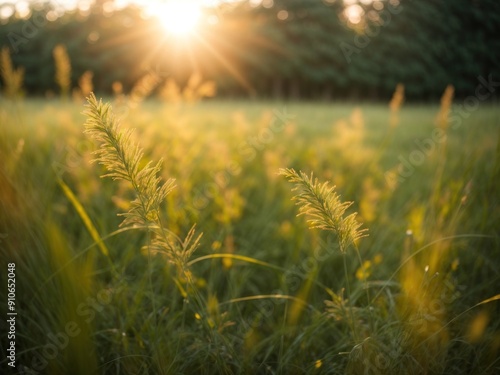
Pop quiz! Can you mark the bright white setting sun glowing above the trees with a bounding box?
[154,1,201,36]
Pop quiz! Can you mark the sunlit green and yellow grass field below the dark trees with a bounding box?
[0,98,500,374]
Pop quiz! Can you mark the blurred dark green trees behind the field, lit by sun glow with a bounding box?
[0,0,500,100]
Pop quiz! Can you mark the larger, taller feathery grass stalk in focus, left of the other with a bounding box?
[84,94,236,373]
